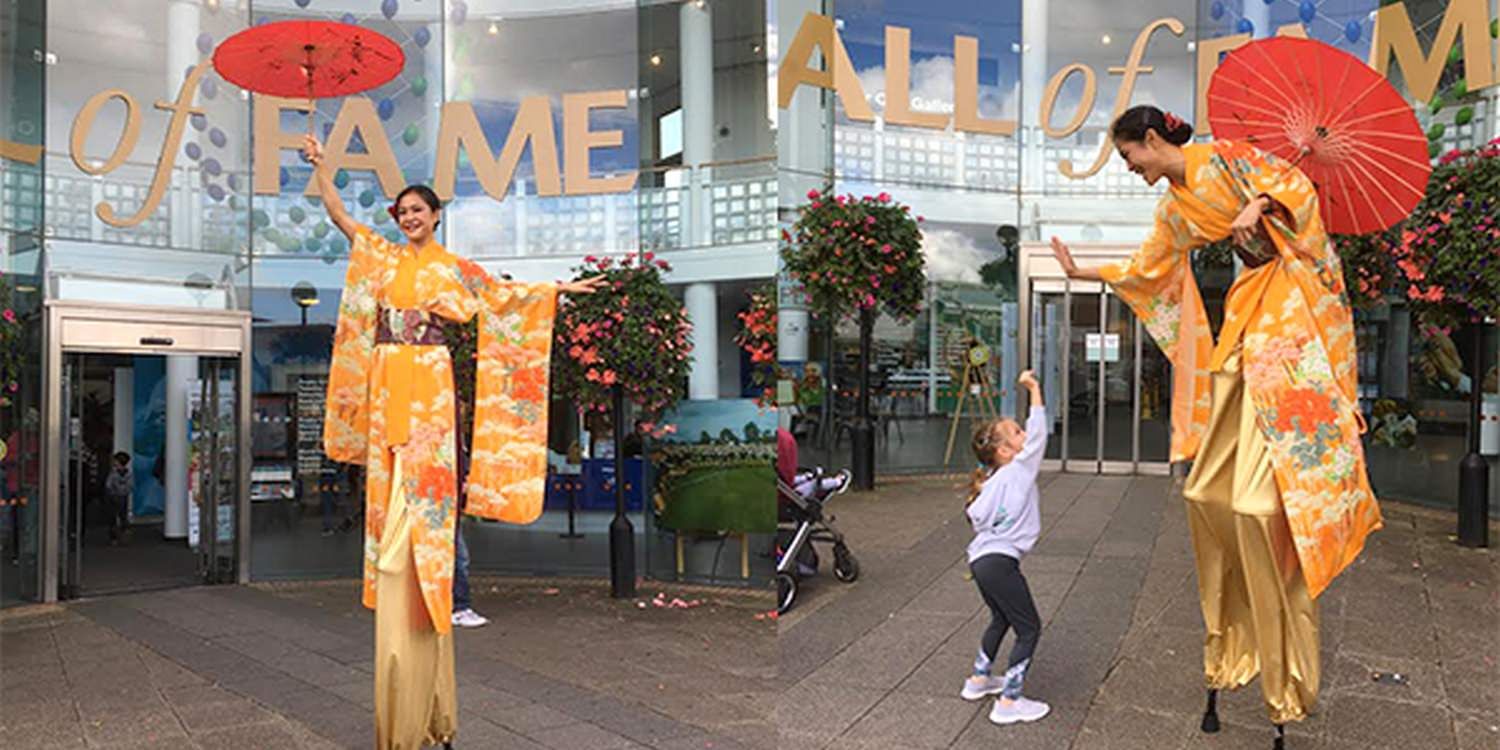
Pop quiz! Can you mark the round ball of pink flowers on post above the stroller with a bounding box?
[782,191,927,321]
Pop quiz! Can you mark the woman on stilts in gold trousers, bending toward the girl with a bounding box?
[1052,107,1382,750]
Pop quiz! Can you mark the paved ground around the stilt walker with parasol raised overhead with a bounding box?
[0,578,780,750]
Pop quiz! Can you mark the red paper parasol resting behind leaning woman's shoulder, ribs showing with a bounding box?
[1208,36,1433,234]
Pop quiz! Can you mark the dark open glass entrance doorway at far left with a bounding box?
[57,353,243,599]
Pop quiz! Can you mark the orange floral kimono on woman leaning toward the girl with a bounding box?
[1101,141,1382,597]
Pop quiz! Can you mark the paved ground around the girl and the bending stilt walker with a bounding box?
[774,474,1500,750]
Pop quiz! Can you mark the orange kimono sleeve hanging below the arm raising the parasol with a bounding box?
[323,227,389,464]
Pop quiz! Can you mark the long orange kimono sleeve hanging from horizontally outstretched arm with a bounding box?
[461,261,557,524]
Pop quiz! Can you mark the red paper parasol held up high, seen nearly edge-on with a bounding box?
[213,21,407,131]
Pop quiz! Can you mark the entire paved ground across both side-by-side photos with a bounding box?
[0,474,1500,750]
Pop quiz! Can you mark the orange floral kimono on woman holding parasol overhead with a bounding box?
[323,228,557,633]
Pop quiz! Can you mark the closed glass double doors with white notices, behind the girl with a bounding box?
[1031,281,1170,474]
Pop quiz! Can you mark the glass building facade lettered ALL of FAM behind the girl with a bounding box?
[776,0,1500,507]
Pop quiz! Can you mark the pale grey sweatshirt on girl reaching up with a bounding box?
[965,407,1047,563]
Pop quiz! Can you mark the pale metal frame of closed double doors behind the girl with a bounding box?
[1017,242,1172,476]
